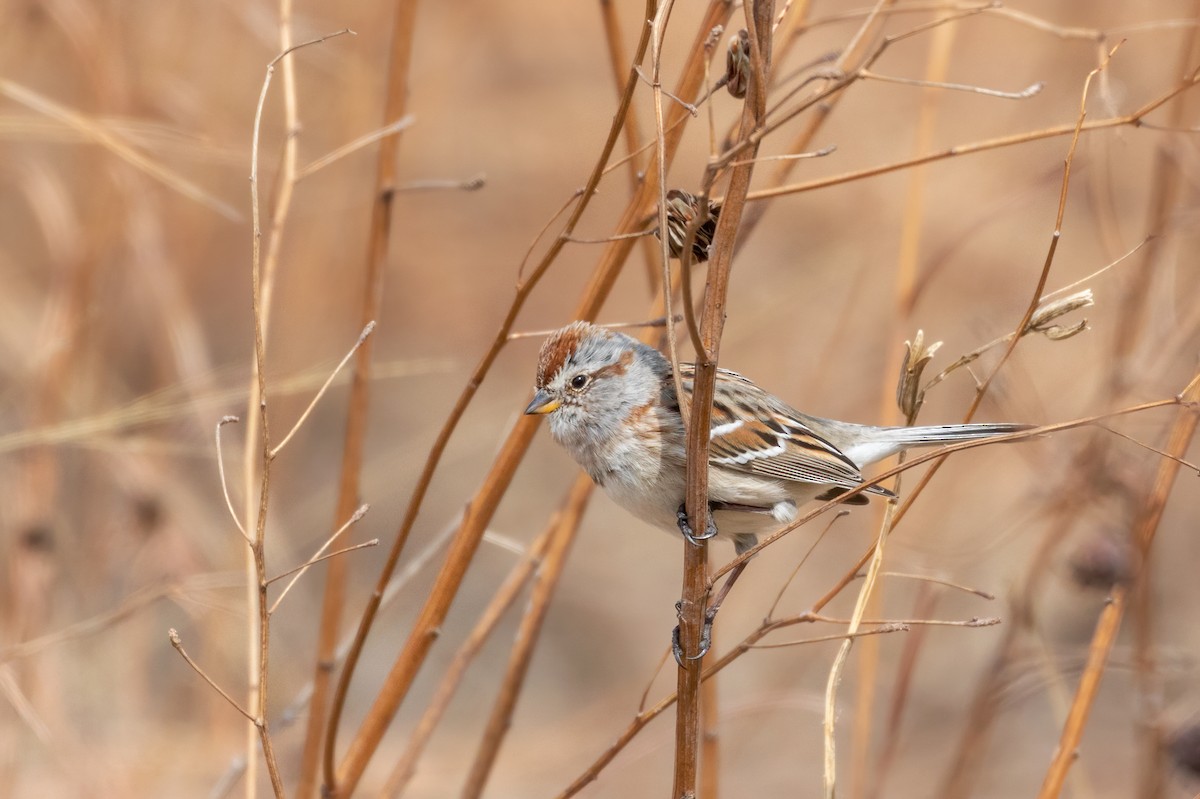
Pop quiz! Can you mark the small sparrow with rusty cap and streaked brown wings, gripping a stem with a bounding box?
[524,322,1027,554]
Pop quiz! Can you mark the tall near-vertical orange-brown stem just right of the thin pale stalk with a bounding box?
[296,7,418,799]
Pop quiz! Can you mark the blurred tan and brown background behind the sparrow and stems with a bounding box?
[0,0,1200,798]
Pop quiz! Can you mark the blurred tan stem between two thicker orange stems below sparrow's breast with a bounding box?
[379,506,561,798]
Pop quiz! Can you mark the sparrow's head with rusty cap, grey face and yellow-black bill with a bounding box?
[526,322,671,450]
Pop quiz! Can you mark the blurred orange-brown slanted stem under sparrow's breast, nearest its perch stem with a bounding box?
[462,475,592,799]
